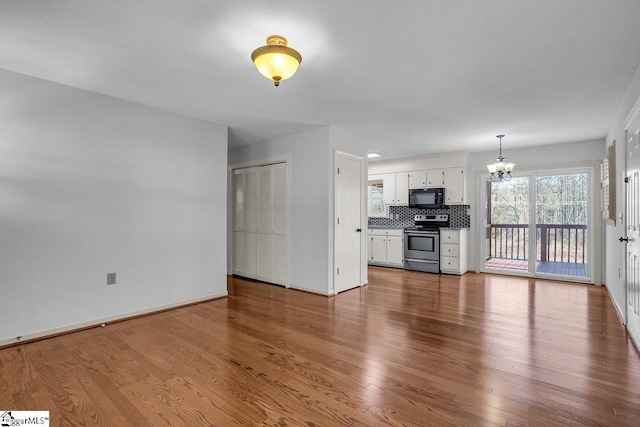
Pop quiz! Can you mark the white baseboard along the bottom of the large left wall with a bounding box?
[0,291,228,347]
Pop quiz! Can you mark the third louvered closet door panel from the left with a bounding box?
[258,166,273,282]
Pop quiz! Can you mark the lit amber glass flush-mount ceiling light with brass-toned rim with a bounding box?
[251,36,302,86]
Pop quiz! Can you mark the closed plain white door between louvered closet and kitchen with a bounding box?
[334,153,363,293]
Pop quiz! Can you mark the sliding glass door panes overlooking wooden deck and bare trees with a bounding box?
[481,168,593,281]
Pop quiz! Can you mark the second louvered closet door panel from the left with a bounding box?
[242,168,259,279]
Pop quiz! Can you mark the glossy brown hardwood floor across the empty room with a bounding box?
[0,267,640,427]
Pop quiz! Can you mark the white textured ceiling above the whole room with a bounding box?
[0,0,640,158]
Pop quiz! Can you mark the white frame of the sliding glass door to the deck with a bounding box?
[476,162,602,285]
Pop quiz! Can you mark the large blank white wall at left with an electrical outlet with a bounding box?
[0,70,227,345]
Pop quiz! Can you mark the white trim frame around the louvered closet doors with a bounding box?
[227,155,291,288]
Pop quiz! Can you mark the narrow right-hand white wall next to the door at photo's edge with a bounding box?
[605,61,640,318]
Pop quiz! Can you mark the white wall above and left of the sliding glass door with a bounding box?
[467,139,605,270]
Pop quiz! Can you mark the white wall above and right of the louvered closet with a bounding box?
[229,127,333,295]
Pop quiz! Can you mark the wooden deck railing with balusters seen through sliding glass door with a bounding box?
[487,224,587,263]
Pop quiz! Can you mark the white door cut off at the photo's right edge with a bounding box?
[625,108,640,347]
